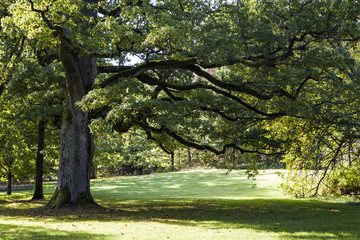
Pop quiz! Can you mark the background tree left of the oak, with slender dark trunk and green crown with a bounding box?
[0,1,64,199]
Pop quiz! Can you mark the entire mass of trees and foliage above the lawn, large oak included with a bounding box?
[0,0,360,208]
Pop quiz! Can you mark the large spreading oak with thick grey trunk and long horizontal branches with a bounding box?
[2,0,360,208]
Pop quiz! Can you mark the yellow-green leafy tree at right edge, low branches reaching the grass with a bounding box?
[283,55,360,197]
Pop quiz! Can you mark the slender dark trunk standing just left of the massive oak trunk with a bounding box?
[32,120,46,200]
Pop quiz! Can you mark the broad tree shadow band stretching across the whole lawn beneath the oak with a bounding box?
[0,199,360,239]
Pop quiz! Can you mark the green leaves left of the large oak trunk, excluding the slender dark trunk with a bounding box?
[0,13,64,184]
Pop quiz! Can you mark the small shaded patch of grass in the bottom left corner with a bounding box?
[0,224,105,240]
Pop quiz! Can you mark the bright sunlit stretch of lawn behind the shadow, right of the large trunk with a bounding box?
[92,170,285,200]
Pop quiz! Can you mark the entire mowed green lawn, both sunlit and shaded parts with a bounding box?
[0,170,360,240]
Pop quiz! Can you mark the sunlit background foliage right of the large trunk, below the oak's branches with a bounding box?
[92,121,170,176]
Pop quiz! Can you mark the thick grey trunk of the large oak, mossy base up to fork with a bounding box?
[48,43,97,208]
